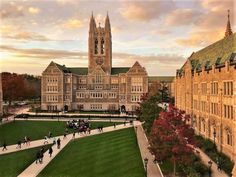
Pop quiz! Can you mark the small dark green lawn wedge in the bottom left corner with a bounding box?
[0,145,49,177]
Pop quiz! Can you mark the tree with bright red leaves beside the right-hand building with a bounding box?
[149,105,195,174]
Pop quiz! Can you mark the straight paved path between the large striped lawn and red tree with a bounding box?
[135,125,163,177]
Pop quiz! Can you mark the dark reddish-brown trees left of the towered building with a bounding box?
[2,72,41,105]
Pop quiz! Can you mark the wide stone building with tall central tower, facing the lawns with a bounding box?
[41,15,148,111]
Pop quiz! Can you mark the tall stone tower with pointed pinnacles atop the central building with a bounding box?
[88,14,112,75]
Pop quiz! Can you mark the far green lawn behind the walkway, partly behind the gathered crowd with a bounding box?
[0,121,120,146]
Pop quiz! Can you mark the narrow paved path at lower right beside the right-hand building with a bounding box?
[195,148,228,177]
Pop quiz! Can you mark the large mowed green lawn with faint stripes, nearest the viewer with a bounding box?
[39,128,145,177]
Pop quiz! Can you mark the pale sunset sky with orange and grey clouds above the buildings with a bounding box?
[0,0,236,76]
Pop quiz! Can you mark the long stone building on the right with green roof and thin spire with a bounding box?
[175,12,236,160]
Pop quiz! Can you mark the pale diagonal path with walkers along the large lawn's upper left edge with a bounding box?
[18,124,136,177]
